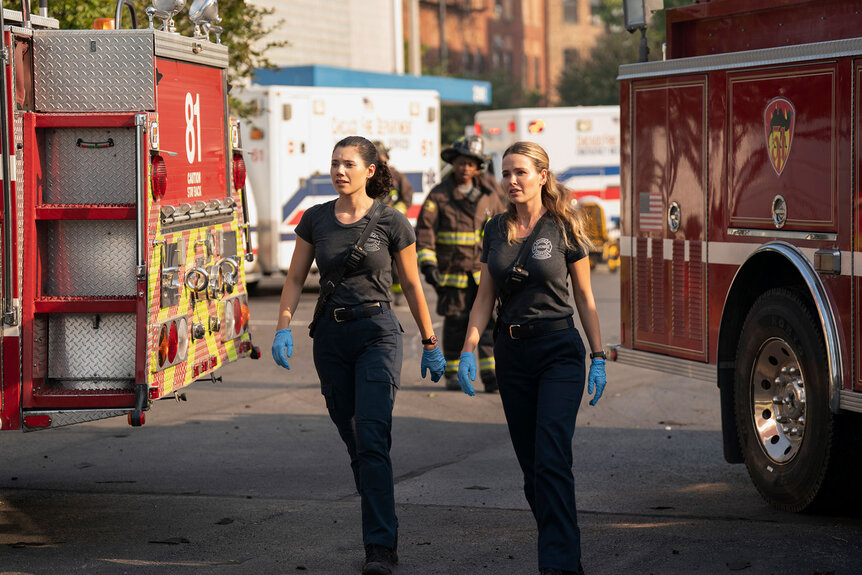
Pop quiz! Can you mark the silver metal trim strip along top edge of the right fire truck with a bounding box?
[617,38,862,80]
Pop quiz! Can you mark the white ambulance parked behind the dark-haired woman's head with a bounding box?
[239,85,440,282]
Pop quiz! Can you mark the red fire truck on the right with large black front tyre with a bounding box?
[612,0,862,511]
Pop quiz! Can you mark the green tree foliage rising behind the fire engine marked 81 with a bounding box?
[45,0,284,117]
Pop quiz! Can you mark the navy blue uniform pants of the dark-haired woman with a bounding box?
[314,310,402,548]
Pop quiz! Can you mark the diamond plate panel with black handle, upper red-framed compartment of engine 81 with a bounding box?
[43,128,136,204]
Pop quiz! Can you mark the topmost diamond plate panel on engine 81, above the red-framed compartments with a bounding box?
[33,30,156,112]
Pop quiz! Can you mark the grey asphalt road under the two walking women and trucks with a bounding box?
[0,269,862,575]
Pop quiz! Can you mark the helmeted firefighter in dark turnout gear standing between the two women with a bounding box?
[416,136,504,393]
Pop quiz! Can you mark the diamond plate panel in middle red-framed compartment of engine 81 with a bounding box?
[44,220,137,297]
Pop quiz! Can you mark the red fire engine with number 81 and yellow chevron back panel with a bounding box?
[0,0,257,431]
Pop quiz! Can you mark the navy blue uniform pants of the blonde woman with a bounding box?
[494,320,586,571]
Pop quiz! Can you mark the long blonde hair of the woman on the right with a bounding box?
[503,142,592,252]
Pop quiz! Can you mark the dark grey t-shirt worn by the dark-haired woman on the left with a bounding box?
[296,200,416,306]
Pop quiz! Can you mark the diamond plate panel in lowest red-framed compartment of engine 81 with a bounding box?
[48,313,135,382]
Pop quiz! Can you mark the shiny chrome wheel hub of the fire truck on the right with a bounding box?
[751,338,806,463]
